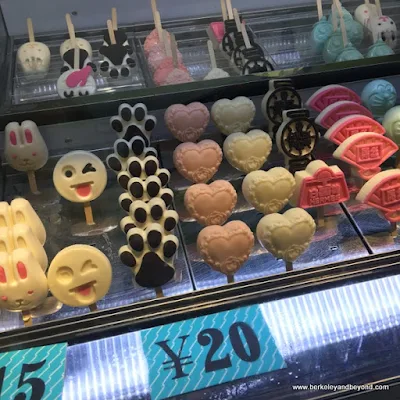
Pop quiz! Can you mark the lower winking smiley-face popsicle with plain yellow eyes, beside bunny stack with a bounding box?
[47,244,112,311]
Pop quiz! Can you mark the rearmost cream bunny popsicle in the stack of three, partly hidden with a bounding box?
[0,198,46,246]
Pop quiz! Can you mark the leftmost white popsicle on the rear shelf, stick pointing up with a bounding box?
[17,18,51,80]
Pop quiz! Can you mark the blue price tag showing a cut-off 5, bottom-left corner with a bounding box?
[0,343,67,400]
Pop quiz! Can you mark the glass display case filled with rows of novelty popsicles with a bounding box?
[0,0,400,400]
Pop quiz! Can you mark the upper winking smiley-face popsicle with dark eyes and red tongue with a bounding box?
[53,150,107,225]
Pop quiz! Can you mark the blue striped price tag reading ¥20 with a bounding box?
[142,305,286,400]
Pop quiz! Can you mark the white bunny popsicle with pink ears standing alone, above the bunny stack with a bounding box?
[4,121,49,194]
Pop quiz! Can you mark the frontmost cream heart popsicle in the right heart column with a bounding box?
[257,208,316,270]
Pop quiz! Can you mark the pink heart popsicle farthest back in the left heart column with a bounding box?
[164,102,210,142]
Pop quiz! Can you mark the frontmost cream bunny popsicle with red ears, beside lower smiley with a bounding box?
[0,249,48,326]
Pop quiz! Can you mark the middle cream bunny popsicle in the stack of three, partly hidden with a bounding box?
[0,224,49,271]
